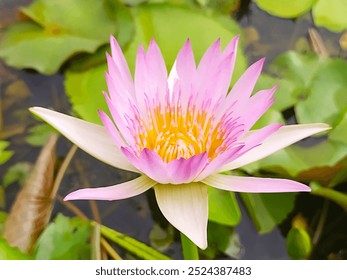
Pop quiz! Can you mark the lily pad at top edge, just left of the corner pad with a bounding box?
[256,0,316,18]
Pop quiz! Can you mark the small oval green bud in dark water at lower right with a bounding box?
[286,227,312,260]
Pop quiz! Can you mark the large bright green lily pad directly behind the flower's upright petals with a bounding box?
[65,4,246,123]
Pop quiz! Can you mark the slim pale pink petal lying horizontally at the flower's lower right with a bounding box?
[202,174,311,193]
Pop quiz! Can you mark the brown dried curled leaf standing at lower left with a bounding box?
[3,135,58,253]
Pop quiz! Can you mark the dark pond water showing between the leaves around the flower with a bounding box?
[0,0,347,259]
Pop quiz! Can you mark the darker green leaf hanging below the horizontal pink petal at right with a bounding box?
[240,193,296,233]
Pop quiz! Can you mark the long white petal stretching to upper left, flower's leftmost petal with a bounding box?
[30,107,139,172]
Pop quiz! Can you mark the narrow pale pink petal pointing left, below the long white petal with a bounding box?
[64,176,157,200]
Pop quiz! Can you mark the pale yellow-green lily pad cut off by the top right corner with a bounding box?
[312,0,347,32]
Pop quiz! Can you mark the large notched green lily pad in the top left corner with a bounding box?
[0,0,116,74]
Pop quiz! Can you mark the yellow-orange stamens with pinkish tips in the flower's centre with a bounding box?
[136,99,236,163]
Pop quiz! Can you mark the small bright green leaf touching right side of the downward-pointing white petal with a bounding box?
[208,188,241,226]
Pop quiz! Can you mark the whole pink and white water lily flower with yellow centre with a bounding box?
[31,37,329,249]
